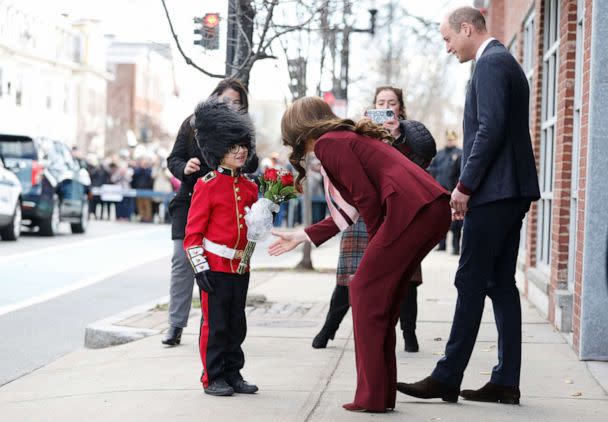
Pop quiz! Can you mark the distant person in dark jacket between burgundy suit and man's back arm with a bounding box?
[428,130,462,255]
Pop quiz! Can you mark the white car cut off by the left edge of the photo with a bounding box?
[0,155,21,240]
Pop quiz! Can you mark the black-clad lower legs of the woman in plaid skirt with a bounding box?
[322,283,418,338]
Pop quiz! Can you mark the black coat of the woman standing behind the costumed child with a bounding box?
[167,116,258,240]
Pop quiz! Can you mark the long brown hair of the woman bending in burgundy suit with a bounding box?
[281,97,394,186]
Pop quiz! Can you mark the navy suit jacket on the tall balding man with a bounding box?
[459,40,540,207]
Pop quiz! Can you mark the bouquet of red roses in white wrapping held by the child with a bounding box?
[236,168,298,274]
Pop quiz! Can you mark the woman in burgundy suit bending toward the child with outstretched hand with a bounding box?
[269,97,451,412]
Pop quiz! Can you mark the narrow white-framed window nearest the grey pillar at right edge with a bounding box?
[568,1,585,292]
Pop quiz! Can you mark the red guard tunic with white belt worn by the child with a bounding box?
[184,167,258,273]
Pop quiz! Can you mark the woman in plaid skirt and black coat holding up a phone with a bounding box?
[312,86,437,353]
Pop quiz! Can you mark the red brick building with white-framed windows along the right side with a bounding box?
[475,0,608,360]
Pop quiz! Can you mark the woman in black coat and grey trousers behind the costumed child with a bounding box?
[162,78,258,346]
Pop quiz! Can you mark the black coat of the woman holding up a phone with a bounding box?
[393,120,437,168]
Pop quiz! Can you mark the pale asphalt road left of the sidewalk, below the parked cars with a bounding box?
[0,221,172,385]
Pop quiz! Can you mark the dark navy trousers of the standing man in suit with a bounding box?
[432,199,530,387]
